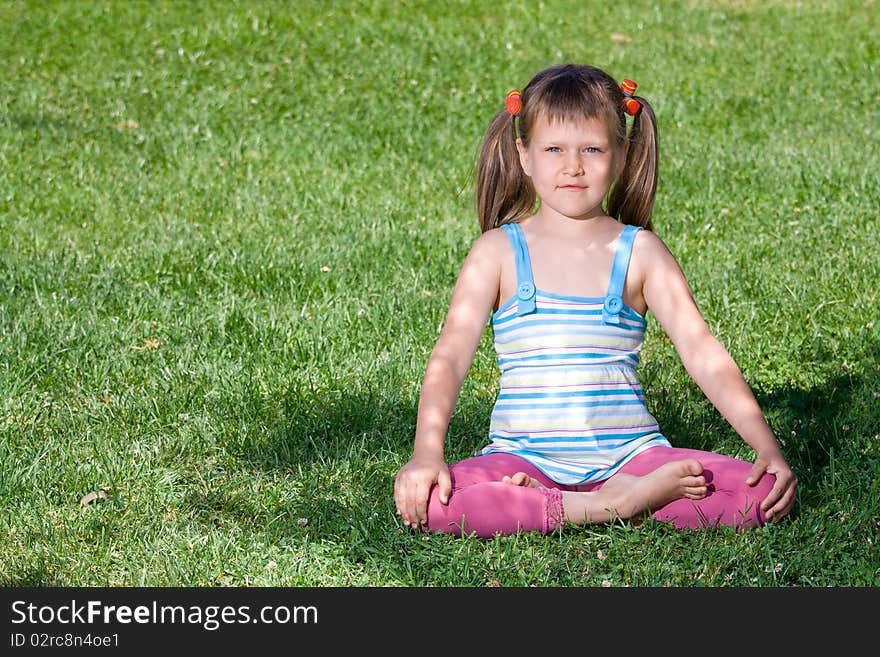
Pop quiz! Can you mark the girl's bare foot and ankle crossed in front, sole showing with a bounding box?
[562,459,706,524]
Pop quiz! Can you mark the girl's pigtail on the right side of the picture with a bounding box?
[608,96,659,230]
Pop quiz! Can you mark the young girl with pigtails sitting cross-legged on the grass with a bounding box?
[394,65,797,537]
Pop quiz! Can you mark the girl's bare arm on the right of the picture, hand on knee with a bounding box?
[634,231,797,520]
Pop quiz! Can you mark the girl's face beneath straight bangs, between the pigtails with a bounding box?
[516,116,625,219]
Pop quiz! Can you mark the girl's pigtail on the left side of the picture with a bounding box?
[476,110,536,233]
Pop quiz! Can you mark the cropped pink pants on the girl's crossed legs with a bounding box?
[427,447,776,538]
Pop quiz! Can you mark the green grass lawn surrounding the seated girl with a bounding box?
[0,0,880,586]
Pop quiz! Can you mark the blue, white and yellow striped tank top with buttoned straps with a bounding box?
[479,223,669,485]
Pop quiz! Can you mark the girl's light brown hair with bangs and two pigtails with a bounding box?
[476,64,658,233]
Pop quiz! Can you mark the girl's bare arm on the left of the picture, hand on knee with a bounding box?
[394,231,507,527]
